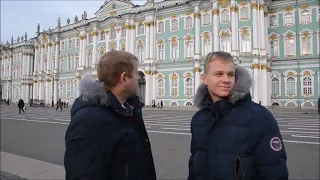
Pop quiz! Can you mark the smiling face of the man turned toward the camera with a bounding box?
[201,59,235,102]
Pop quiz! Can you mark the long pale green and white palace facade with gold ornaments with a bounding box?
[1,0,320,107]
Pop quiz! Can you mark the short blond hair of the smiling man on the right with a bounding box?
[204,51,234,73]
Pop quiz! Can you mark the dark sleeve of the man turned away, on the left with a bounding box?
[64,112,112,180]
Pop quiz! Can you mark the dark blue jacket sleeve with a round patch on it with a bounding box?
[254,112,288,180]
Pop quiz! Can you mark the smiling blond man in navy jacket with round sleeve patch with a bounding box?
[188,52,288,180]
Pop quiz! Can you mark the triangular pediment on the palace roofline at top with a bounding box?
[95,0,134,17]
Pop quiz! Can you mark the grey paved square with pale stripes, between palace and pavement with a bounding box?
[1,106,320,179]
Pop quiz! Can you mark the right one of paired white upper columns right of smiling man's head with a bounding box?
[258,4,267,56]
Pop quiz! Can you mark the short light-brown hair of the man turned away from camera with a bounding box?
[97,50,138,88]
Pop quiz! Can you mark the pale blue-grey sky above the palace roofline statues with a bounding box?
[1,0,146,44]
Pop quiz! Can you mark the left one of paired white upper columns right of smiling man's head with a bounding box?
[251,1,259,54]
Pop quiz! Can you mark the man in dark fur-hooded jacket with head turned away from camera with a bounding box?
[64,51,156,180]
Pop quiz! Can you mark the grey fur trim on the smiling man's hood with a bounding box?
[194,66,252,108]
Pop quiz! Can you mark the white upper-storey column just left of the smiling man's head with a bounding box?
[193,6,201,59]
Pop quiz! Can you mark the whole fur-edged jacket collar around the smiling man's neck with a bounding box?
[194,66,252,108]
